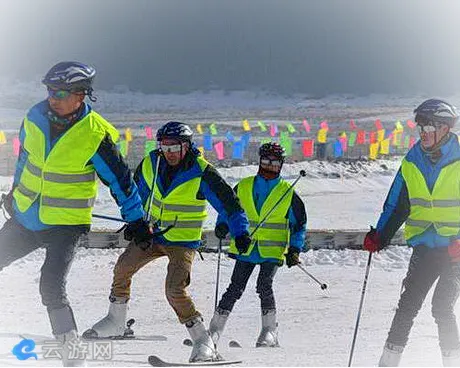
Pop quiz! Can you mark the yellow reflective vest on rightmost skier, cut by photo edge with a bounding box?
[401,159,460,240]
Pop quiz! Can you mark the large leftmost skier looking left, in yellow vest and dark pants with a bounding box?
[0,62,150,366]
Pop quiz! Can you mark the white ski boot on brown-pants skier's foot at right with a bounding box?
[185,317,219,363]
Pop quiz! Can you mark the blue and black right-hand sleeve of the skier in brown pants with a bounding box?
[200,165,249,238]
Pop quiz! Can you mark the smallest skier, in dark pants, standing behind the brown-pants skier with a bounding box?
[209,142,307,347]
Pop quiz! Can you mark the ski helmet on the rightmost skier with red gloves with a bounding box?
[414,98,459,128]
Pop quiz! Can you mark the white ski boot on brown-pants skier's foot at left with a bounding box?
[83,298,128,339]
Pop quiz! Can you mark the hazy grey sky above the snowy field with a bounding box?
[0,0,460,96]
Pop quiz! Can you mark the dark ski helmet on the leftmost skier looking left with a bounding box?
[42,61,96,96]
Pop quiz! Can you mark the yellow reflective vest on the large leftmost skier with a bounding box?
[13,111,119,225]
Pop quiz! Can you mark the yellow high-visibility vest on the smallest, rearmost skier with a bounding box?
[229,176,294,260]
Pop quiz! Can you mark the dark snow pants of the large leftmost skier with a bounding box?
[0,219,88,335]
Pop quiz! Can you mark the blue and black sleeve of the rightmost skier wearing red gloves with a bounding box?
[376,169,410,246]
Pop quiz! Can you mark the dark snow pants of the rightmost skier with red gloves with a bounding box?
[387,246,460,350]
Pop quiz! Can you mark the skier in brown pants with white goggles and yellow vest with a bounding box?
[85,121,251,362]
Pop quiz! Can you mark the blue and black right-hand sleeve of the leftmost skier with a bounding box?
[91,135,144,222]
